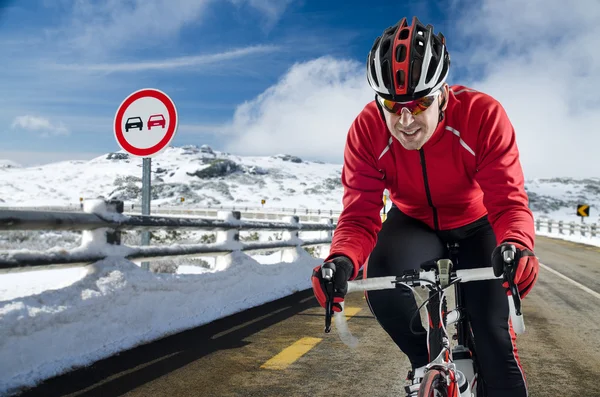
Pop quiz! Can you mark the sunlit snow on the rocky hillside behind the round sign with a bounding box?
[0,146,342,210]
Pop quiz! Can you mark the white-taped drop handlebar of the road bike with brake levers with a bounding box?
[325,266,525,347]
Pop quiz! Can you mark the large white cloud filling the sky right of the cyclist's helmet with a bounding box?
[449,0,600,178]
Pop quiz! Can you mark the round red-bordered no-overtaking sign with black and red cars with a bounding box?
[113,88,179,158]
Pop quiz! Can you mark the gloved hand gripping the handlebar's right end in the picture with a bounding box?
[492,242,540,298]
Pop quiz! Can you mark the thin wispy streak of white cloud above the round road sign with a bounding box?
[57,45,279,73]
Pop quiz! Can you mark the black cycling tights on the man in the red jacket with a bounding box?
[365,207,527,397]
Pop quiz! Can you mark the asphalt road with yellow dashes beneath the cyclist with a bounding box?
[14,237,600,397]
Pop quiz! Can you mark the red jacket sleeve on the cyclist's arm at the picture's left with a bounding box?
[326,111,385,280]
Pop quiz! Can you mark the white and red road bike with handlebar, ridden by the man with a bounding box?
[333,259,525,397]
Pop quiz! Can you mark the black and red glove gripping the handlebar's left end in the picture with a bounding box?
[311,256,354,312]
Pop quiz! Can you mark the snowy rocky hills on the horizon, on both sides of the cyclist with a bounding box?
[0,145,600,222]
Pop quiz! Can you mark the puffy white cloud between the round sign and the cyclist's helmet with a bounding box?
[226,57,373,163]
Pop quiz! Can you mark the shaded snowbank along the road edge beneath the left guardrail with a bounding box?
[0,249,321,394]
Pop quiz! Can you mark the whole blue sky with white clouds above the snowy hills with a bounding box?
[0,0,600,176]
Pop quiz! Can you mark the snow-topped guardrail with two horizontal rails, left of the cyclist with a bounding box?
[0,200,336,269]
